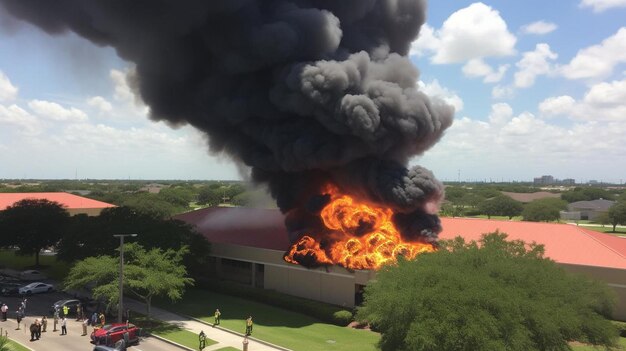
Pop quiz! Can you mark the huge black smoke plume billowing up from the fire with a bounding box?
[0,0,453,248]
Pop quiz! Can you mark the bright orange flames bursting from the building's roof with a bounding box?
[284,186,435,269]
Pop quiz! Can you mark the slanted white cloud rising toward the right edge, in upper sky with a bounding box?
[561,27,626,79]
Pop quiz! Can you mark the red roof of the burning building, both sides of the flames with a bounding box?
[175,207,626,269]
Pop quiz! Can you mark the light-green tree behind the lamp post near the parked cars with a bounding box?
[64,243,193,316]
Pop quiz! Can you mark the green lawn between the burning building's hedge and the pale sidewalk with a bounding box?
[159,289,380,351]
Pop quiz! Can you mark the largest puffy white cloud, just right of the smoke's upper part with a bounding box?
[411,2,517,64]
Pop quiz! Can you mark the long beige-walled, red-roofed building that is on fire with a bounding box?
[174,207,626,320]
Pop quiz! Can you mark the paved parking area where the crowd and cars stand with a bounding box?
[0,292,186,351]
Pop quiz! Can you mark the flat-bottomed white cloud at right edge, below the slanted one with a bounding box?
[539,80,626,120]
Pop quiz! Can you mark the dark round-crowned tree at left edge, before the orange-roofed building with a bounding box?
[0,199,70,266]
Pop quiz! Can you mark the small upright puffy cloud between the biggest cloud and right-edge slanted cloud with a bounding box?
[515,43,558,88]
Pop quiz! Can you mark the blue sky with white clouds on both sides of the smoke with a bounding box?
[0,0,626,183]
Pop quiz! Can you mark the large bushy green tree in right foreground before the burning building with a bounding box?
[357,232,617,351]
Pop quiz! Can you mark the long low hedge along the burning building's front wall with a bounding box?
[196,281,352,327]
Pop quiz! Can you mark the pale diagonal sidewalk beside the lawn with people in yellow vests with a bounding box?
[124,298,288,351]
